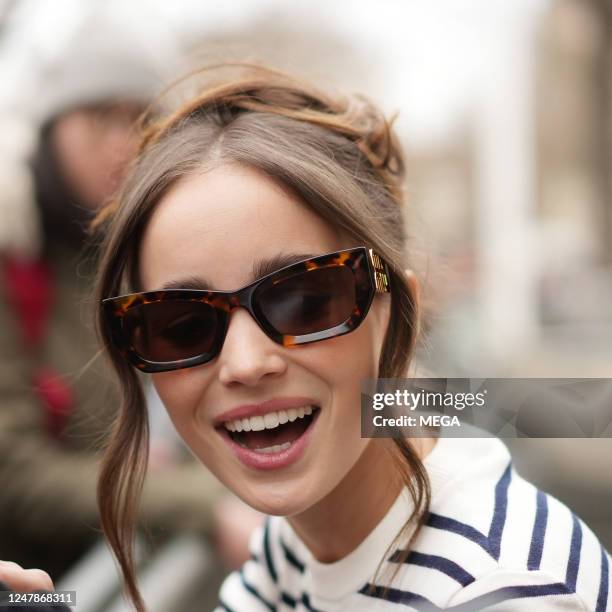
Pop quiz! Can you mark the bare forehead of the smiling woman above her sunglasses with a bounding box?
[140,165,351,291]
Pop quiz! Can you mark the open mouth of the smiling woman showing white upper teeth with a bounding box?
[222,406,320,454]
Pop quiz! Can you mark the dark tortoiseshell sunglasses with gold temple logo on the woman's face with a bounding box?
[102,247,390,372]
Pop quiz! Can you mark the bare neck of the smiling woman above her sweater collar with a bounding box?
[289,438,435,563]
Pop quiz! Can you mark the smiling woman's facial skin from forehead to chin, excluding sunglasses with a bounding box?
[140,165,390,516]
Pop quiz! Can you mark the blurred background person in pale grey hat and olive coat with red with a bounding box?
[0,5,259,592]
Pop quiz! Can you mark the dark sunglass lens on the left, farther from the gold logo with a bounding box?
[123,300,219,362]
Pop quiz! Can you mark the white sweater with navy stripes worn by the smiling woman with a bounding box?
[215,438,612,612]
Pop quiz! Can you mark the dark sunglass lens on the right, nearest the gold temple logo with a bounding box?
[257,266,355,336]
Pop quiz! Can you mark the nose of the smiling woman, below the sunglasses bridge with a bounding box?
[219,308,288,386]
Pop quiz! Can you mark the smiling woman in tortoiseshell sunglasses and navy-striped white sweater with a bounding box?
[16,66,610,612]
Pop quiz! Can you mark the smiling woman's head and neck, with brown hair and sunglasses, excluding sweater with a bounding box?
[91,62,431,609]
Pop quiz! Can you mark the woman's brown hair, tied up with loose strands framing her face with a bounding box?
[94,64,430,612]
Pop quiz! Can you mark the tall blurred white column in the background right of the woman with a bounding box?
[475,11,539,376]
